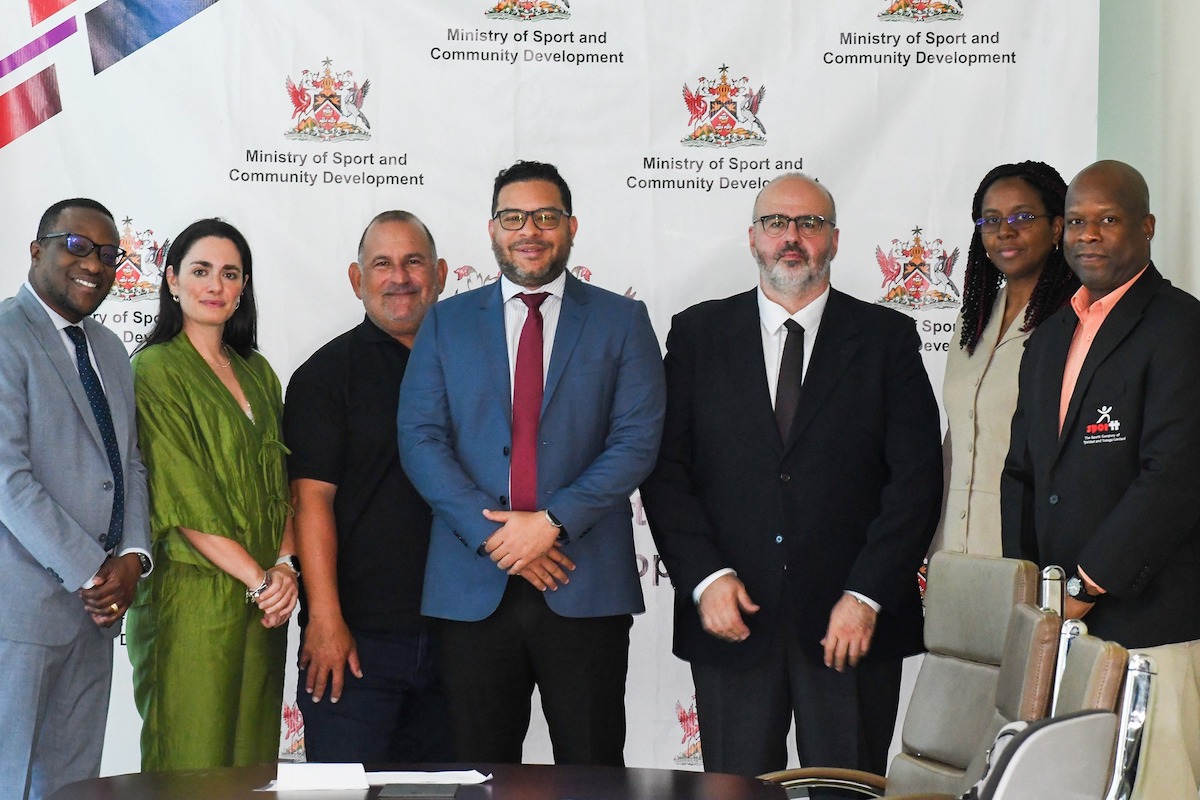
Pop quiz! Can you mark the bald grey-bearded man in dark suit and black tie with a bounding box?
[642,174,942,775]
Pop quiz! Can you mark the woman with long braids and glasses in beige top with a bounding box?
[930,161,1079,555]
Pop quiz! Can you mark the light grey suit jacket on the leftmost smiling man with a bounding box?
[0,287,150,645]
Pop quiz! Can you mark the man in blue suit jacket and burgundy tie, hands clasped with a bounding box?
[398,161,665,766]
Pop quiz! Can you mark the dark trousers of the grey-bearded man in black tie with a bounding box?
[691,630,902,796]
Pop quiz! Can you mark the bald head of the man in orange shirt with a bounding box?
[1063,161,1154,302]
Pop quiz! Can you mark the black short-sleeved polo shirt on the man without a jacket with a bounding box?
[283,319,432,632]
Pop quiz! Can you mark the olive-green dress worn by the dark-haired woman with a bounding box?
[126,333,289,771]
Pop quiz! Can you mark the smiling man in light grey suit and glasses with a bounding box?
[0,199,152,800]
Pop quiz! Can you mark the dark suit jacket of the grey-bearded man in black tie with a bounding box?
[642,290,942,668]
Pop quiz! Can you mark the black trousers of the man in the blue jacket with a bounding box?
[438,577,632,766]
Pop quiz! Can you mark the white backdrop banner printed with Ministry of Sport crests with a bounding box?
[0,0,1099,772]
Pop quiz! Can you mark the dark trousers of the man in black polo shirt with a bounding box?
[296,631,455,764]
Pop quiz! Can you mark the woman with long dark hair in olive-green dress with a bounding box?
[127,219,299,771]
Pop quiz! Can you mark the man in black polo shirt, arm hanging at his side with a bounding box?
[283,211,452,763]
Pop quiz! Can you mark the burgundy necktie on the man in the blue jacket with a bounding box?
[509,291,550,511]
